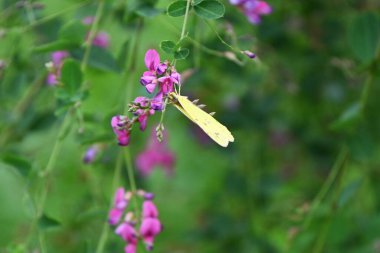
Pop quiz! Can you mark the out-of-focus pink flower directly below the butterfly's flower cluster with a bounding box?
[136,131,175,176]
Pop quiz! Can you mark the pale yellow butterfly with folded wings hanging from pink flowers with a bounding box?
[169,92,234,147]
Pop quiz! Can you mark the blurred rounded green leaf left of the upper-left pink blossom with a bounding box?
[59,21,87,45]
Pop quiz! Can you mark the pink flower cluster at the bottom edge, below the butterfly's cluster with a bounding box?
[108,188,162,253]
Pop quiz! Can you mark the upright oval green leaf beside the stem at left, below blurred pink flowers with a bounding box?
[61,59,82,96]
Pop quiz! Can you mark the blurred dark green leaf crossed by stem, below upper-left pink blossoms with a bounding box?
[72,47,121,73]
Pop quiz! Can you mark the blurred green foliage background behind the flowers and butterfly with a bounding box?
[0,0,380,253]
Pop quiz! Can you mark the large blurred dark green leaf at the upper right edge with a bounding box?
[348,13,380,63]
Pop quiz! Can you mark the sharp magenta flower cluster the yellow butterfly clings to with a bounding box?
[111,49,181,146]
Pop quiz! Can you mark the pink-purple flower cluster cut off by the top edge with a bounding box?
[230,0,272,24]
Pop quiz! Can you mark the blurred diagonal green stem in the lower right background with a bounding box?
[303,146,348,229]
